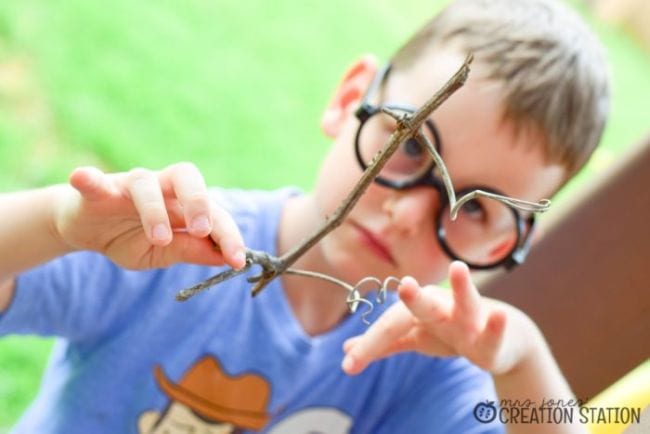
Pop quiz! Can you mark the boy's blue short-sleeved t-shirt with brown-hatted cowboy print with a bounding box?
[0,189,503,434]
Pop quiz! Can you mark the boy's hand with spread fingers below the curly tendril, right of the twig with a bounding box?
[342,262,534,374]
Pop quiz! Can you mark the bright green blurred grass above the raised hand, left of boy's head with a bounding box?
[0,0,446,187]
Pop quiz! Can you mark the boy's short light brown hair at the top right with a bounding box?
[391,0,610,175]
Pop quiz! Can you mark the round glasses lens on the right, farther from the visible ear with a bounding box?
[439,197,518,267]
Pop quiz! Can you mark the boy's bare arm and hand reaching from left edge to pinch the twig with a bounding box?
[0,163,245,312]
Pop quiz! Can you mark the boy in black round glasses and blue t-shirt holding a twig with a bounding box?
[0,0,608,433]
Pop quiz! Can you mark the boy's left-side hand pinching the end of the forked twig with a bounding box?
[53,163,245,269]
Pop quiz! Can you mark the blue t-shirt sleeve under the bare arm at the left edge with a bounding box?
[0,252,165,341]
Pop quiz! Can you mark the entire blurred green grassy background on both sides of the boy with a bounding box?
[0,0,650,433]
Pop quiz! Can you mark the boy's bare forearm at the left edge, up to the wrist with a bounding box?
[0,185,71,282]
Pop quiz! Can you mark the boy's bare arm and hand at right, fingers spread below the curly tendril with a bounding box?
[342,262,586,433]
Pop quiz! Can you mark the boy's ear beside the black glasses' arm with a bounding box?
[321,54,377,137]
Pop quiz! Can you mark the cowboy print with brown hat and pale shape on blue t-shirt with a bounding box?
[138,356,351,434]
